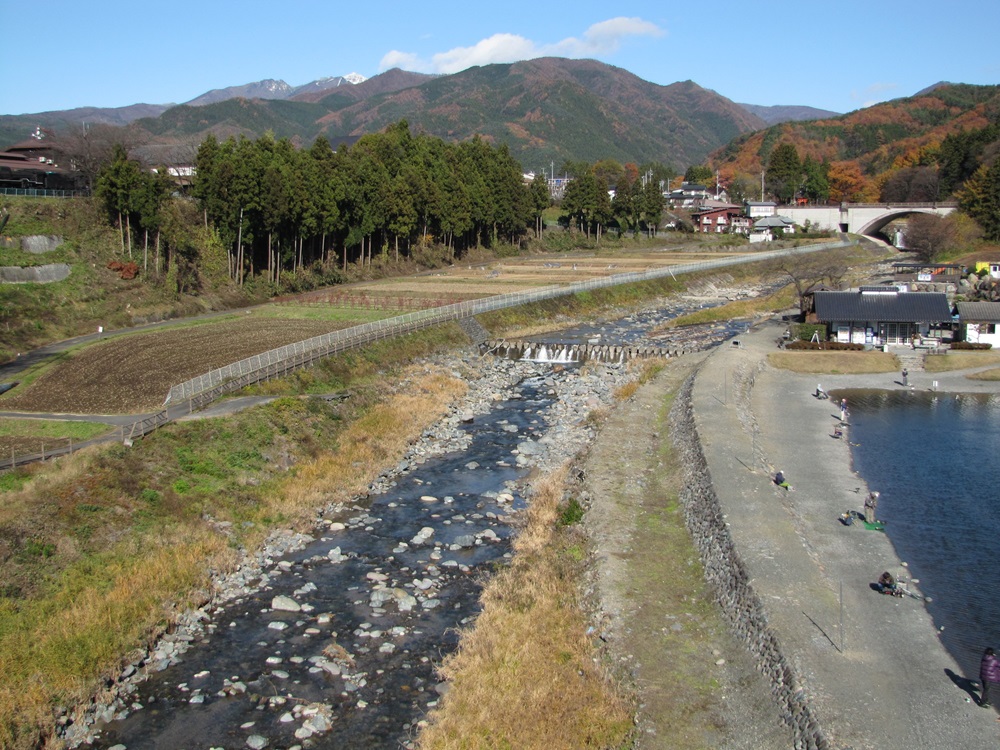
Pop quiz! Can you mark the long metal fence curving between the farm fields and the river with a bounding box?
[0,240,851,469]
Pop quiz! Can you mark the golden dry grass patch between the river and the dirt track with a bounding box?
[418,472,632,750]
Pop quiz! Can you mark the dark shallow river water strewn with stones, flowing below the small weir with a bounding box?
[87,377,553,750]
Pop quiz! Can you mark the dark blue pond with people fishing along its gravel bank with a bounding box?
[835,391,1000,679]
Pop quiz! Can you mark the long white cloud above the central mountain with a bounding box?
[379,17,664,73]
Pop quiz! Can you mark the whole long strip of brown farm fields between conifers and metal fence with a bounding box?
[0,251,752,414]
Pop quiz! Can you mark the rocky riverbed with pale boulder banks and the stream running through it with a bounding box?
[58,286,760,750]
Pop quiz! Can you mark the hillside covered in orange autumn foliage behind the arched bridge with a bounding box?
[711,84,1000,203]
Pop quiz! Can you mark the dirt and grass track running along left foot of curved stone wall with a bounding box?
[583,355,791,750]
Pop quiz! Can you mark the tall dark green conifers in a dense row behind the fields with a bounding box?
[95,121,550,284]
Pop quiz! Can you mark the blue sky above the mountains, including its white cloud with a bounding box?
[0,0,1000,114]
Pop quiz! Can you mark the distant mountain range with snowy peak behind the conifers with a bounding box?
[0,58,960,171]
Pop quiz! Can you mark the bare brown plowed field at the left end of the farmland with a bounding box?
[0,316,349,414]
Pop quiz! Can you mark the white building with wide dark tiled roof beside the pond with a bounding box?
[810,286,953,346]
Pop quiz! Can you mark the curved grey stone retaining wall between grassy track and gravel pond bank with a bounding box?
[670,372,832,750]
